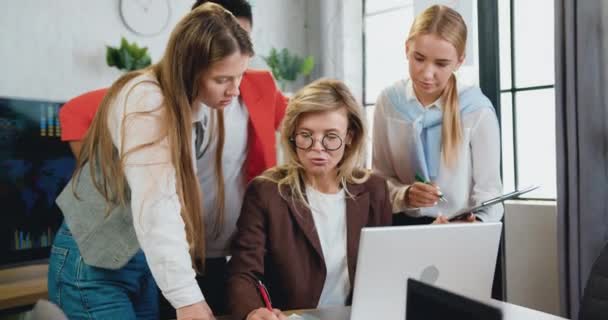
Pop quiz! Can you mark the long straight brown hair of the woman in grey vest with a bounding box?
[74,3,253,261]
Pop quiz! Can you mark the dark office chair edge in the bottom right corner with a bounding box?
[578,243,608,320]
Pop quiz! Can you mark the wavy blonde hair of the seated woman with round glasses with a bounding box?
[258,79,370,206]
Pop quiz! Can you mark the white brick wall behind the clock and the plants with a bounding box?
[0,0,318,101]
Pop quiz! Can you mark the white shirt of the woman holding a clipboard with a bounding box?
[372,80,504,221]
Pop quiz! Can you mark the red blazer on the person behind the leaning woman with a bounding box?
[59,69,287,181]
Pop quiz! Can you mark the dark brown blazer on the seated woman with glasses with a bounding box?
[228,175,392,319]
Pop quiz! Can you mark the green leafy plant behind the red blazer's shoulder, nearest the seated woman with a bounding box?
[264,48,315,91]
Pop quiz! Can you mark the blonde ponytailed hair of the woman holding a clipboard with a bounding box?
[407,5,467,165]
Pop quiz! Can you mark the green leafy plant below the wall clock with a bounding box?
[106,37,152,71]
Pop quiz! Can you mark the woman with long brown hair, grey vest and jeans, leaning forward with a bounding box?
[48,4,253,319]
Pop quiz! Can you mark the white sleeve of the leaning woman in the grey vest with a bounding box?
[108,73,204,308]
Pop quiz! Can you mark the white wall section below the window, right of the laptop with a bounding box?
[505,201,559,315]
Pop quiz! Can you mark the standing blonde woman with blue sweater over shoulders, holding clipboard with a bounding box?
[373,5,503,223]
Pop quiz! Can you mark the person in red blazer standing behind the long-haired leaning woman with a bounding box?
[59,0,287,317]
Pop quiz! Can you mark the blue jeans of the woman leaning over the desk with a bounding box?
[48,222,159,319]
